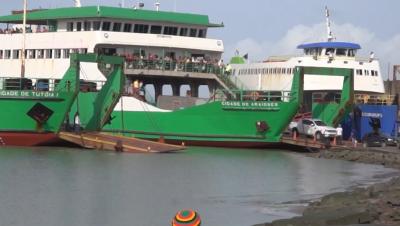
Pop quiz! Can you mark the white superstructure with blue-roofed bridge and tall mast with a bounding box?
[231,6,385,94]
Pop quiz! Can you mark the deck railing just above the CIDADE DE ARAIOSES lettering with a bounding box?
[210,90,292,102]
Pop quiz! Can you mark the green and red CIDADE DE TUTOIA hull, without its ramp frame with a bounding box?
[0,91,76,146]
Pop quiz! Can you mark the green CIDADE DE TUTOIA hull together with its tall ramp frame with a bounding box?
[0,54,124,146]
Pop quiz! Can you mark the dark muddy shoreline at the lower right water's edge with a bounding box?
[255,147,400,226]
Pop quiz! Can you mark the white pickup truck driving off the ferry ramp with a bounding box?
[289,119,337,140]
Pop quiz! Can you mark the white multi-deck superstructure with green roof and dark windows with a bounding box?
[0,4,224,96]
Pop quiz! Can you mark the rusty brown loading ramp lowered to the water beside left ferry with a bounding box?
[58,132,185,153]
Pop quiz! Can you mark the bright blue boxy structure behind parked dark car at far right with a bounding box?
[342,104,397,140]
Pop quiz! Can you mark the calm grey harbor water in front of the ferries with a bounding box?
[0,147,393,226]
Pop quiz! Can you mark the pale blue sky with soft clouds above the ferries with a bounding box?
[0,0,400,78]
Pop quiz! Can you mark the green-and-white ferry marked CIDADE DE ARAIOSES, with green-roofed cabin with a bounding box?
[0,1,354,147]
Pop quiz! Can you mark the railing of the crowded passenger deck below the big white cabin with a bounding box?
[125,58,225,74]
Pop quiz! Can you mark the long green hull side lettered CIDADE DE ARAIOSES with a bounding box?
[103,102,298,147]
